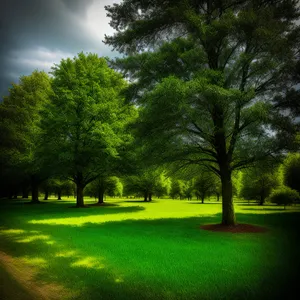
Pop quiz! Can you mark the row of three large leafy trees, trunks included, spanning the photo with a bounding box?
[0,0,300,225]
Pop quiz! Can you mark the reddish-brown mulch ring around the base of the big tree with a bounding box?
[200,224,268,233]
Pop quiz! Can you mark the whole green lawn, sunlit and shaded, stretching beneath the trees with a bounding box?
[0,199,300,300]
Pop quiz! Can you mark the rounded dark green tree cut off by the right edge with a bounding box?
[283,153,300,193]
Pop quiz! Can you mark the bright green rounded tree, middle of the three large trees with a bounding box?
[42,53,133,207]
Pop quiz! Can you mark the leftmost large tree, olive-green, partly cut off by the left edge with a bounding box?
[0,71,52,203]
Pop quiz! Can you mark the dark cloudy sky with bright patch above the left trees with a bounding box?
[0,0,121,101]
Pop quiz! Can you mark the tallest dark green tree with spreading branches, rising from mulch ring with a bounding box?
[105,0,300,225]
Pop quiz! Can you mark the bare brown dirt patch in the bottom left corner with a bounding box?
[0,251,72,300]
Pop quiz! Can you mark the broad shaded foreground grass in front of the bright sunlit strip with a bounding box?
[0,207,300,300]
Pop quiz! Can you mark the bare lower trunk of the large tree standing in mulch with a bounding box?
[221,168,236,226]
